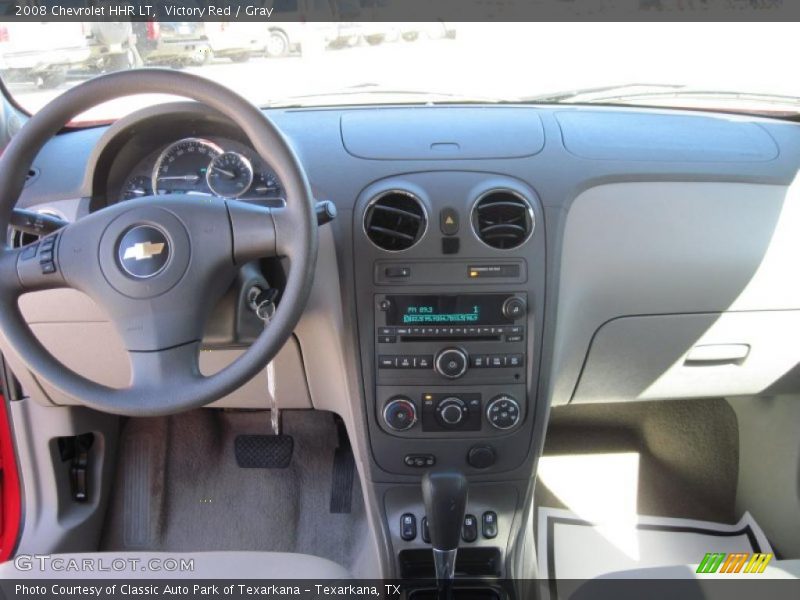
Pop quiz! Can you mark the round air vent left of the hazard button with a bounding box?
[364,190,428,252]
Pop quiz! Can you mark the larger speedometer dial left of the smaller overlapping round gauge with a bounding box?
[153,138,222,194]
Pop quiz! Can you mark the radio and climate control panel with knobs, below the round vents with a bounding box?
[375,292,527,440]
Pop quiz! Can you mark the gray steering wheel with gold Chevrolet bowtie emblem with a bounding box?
[0,69,317,416]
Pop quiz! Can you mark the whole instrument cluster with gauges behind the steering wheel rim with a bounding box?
[120,137,283,200]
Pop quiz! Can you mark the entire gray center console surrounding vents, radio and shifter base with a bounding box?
[353,172,545,577]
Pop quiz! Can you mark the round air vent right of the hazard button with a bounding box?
[472,190,533,250]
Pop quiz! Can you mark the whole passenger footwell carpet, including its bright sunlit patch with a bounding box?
[535,400,740,535]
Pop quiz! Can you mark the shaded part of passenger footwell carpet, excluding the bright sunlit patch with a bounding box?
[535,400,739,523]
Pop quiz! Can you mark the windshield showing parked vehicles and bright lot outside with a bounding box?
[0,21,800,121]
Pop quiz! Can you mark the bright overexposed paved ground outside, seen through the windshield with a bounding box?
[6,23,800,118]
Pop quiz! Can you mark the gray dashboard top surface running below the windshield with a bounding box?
[15,103,800,210]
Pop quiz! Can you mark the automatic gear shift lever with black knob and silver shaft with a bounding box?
[422,471,468,585]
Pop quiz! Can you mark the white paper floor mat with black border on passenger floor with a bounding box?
[537,507,772,592]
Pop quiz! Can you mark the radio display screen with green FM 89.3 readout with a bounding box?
[386,294,511,326]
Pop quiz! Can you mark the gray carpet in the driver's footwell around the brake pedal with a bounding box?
[101,409,366,570]
